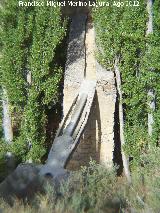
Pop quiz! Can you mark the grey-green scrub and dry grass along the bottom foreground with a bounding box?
[0,152,160,213]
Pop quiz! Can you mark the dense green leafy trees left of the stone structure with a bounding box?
[0,0,66,162]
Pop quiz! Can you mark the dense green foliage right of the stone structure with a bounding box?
[93,0,160,164]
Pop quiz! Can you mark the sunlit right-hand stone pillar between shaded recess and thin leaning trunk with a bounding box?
[96,63,116,166]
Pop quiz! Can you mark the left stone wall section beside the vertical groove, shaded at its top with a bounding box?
[63,15,87,118]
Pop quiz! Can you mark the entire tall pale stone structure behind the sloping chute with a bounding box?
[63,14,116,170]
